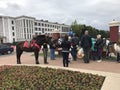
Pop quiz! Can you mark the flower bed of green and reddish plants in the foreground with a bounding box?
[0,66,105,90]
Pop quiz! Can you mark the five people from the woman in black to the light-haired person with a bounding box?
[61,30,105,67]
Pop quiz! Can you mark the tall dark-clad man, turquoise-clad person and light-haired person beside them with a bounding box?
[81,31,105,63]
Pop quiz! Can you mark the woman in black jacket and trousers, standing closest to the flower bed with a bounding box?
[61,35,71,67]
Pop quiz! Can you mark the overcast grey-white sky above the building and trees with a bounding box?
[0,0,120,30]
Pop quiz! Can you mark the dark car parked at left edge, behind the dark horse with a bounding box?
[0,44,14,54]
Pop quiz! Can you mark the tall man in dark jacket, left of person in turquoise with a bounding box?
[81,30,92,63]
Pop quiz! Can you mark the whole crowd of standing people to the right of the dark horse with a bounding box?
[43,30,117,67]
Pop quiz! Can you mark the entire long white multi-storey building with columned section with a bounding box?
[0,16,70,43]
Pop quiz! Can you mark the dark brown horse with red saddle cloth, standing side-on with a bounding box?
[16,35,47,64]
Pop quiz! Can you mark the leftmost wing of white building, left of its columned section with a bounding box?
[0,16,16,42]
